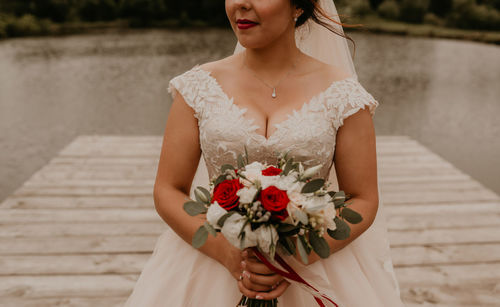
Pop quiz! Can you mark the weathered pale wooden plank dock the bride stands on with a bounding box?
[0,136,500,307]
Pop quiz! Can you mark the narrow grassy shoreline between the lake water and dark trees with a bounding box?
[0,16,500,45]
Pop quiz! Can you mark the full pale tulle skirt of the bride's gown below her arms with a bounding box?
[125,199,404,307]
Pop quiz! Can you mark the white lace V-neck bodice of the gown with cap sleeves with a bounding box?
[168,65,379,179]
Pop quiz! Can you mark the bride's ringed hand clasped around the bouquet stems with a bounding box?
[238,249,290,300]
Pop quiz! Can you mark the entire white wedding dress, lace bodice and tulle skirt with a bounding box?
[125,65,404,307]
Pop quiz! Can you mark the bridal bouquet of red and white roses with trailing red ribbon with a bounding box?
[184,148,362,306]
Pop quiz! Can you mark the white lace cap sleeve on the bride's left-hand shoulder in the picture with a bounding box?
[167,69,202,119]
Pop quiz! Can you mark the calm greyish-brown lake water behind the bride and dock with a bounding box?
[0,29,500,200]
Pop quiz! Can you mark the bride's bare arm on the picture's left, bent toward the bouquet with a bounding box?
[153,91,238,265]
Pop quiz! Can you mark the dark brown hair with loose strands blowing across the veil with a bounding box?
[290,0,363,58]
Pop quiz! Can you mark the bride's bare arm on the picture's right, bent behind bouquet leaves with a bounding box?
[296,108,379,264]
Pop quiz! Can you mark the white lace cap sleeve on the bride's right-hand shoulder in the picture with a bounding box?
[330,79,379,130]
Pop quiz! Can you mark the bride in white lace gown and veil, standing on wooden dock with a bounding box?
[125,0,404,307]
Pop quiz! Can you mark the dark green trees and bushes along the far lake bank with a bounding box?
[0,0,500,37]
